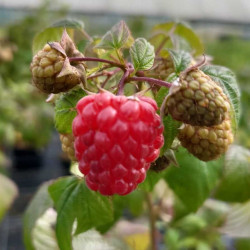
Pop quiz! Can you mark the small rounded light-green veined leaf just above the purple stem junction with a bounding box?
[130,38,155,71]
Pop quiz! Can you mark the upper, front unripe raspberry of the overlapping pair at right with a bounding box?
[166,69,230,126]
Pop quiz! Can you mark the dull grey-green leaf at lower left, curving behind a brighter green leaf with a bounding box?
[23,182,53,250]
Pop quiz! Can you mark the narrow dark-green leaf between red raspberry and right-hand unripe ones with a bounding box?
[161,115,181,153]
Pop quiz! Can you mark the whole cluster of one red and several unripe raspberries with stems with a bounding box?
[31,27,236,195]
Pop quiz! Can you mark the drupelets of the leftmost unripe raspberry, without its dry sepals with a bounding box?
[30,44,81,93]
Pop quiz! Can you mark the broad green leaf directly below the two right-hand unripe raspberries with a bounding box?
[165,148,222,217]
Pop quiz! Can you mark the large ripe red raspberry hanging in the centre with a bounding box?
[73,92,164,195]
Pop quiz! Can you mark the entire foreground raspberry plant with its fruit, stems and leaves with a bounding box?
[24,20,250,250]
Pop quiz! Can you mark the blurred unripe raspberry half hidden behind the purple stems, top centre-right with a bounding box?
[145,57,175,80]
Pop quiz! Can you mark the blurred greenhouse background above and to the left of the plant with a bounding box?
[0,0,250,250]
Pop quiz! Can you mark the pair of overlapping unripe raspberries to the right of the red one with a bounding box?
[166,69,233,161]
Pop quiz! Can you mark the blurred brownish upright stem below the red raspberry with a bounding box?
[145,192,157,250]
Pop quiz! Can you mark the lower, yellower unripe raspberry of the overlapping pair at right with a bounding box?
[178,119,233,161]
